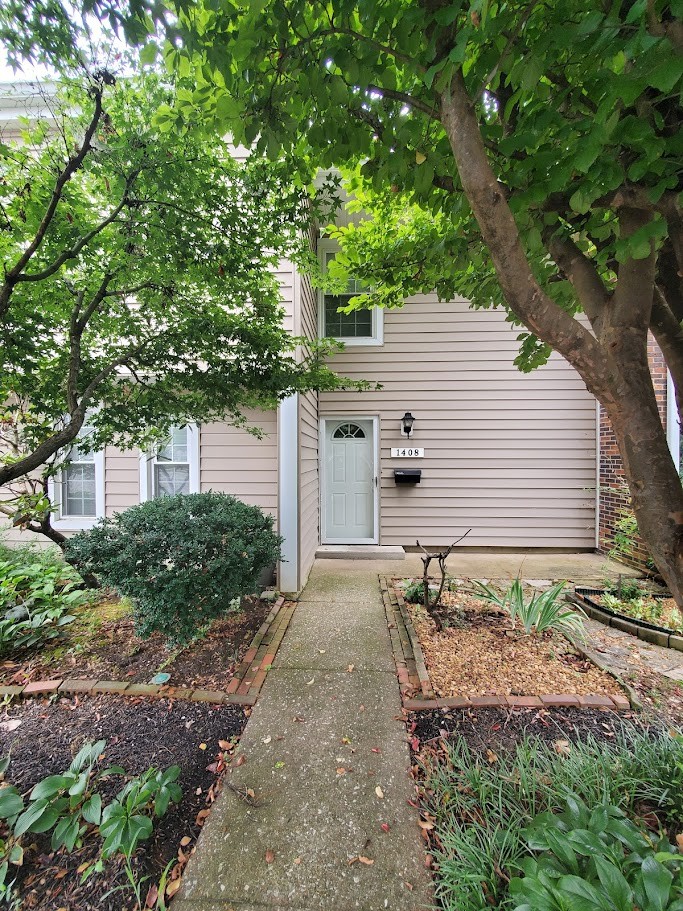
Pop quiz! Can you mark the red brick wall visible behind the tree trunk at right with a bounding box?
[599,335,666,569]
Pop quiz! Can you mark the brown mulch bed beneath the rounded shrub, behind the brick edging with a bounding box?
[0,597,273,690]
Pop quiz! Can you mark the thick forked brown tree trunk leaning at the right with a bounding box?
[441,80,683,606]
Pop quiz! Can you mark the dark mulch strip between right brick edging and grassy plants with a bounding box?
[410,709,641,752]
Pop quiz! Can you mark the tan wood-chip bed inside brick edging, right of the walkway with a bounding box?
[406,592,622,698]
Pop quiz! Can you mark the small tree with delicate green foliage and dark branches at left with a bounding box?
[0,70,350,544]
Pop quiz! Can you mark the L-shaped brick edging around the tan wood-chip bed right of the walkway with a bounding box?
[379,576,631,712]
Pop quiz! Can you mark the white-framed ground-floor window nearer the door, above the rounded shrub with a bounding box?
[140,424,199,500]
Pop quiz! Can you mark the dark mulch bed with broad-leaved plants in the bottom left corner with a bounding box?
[0,696,247,911]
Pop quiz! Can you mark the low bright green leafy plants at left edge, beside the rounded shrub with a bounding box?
[0,547,86,657]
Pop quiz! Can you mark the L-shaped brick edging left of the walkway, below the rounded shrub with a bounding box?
[0,597,296,706]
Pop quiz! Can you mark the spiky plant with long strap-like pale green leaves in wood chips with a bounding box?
[474,578,585,638]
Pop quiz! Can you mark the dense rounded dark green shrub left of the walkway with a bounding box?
[65,493,281,645]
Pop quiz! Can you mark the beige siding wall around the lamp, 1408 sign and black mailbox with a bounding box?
[320,295,596,548]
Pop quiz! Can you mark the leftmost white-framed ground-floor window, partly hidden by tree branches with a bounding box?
[50,427,104,529]
